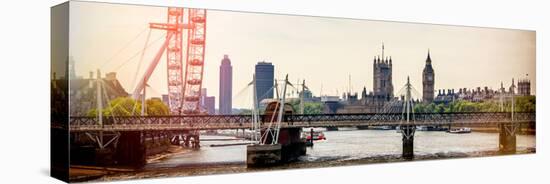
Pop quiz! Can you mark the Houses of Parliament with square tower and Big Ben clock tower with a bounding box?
[334,45,531,113]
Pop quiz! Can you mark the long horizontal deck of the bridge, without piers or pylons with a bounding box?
[69,112,536,132]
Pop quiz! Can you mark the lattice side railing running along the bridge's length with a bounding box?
[69,112,536,127]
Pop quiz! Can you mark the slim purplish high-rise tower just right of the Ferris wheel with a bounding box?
[219,55,233,114]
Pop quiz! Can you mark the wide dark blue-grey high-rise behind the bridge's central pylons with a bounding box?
[254,61,275,102]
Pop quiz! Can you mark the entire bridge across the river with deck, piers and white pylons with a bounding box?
[63,78,536,167]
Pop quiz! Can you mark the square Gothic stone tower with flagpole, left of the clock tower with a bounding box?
[372,45,393,100]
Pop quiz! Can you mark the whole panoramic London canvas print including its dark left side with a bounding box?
[54,1,540,182]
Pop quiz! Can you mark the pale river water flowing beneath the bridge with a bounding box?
[98,129,536,180]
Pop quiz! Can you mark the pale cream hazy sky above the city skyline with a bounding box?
[70,2,536,108]
